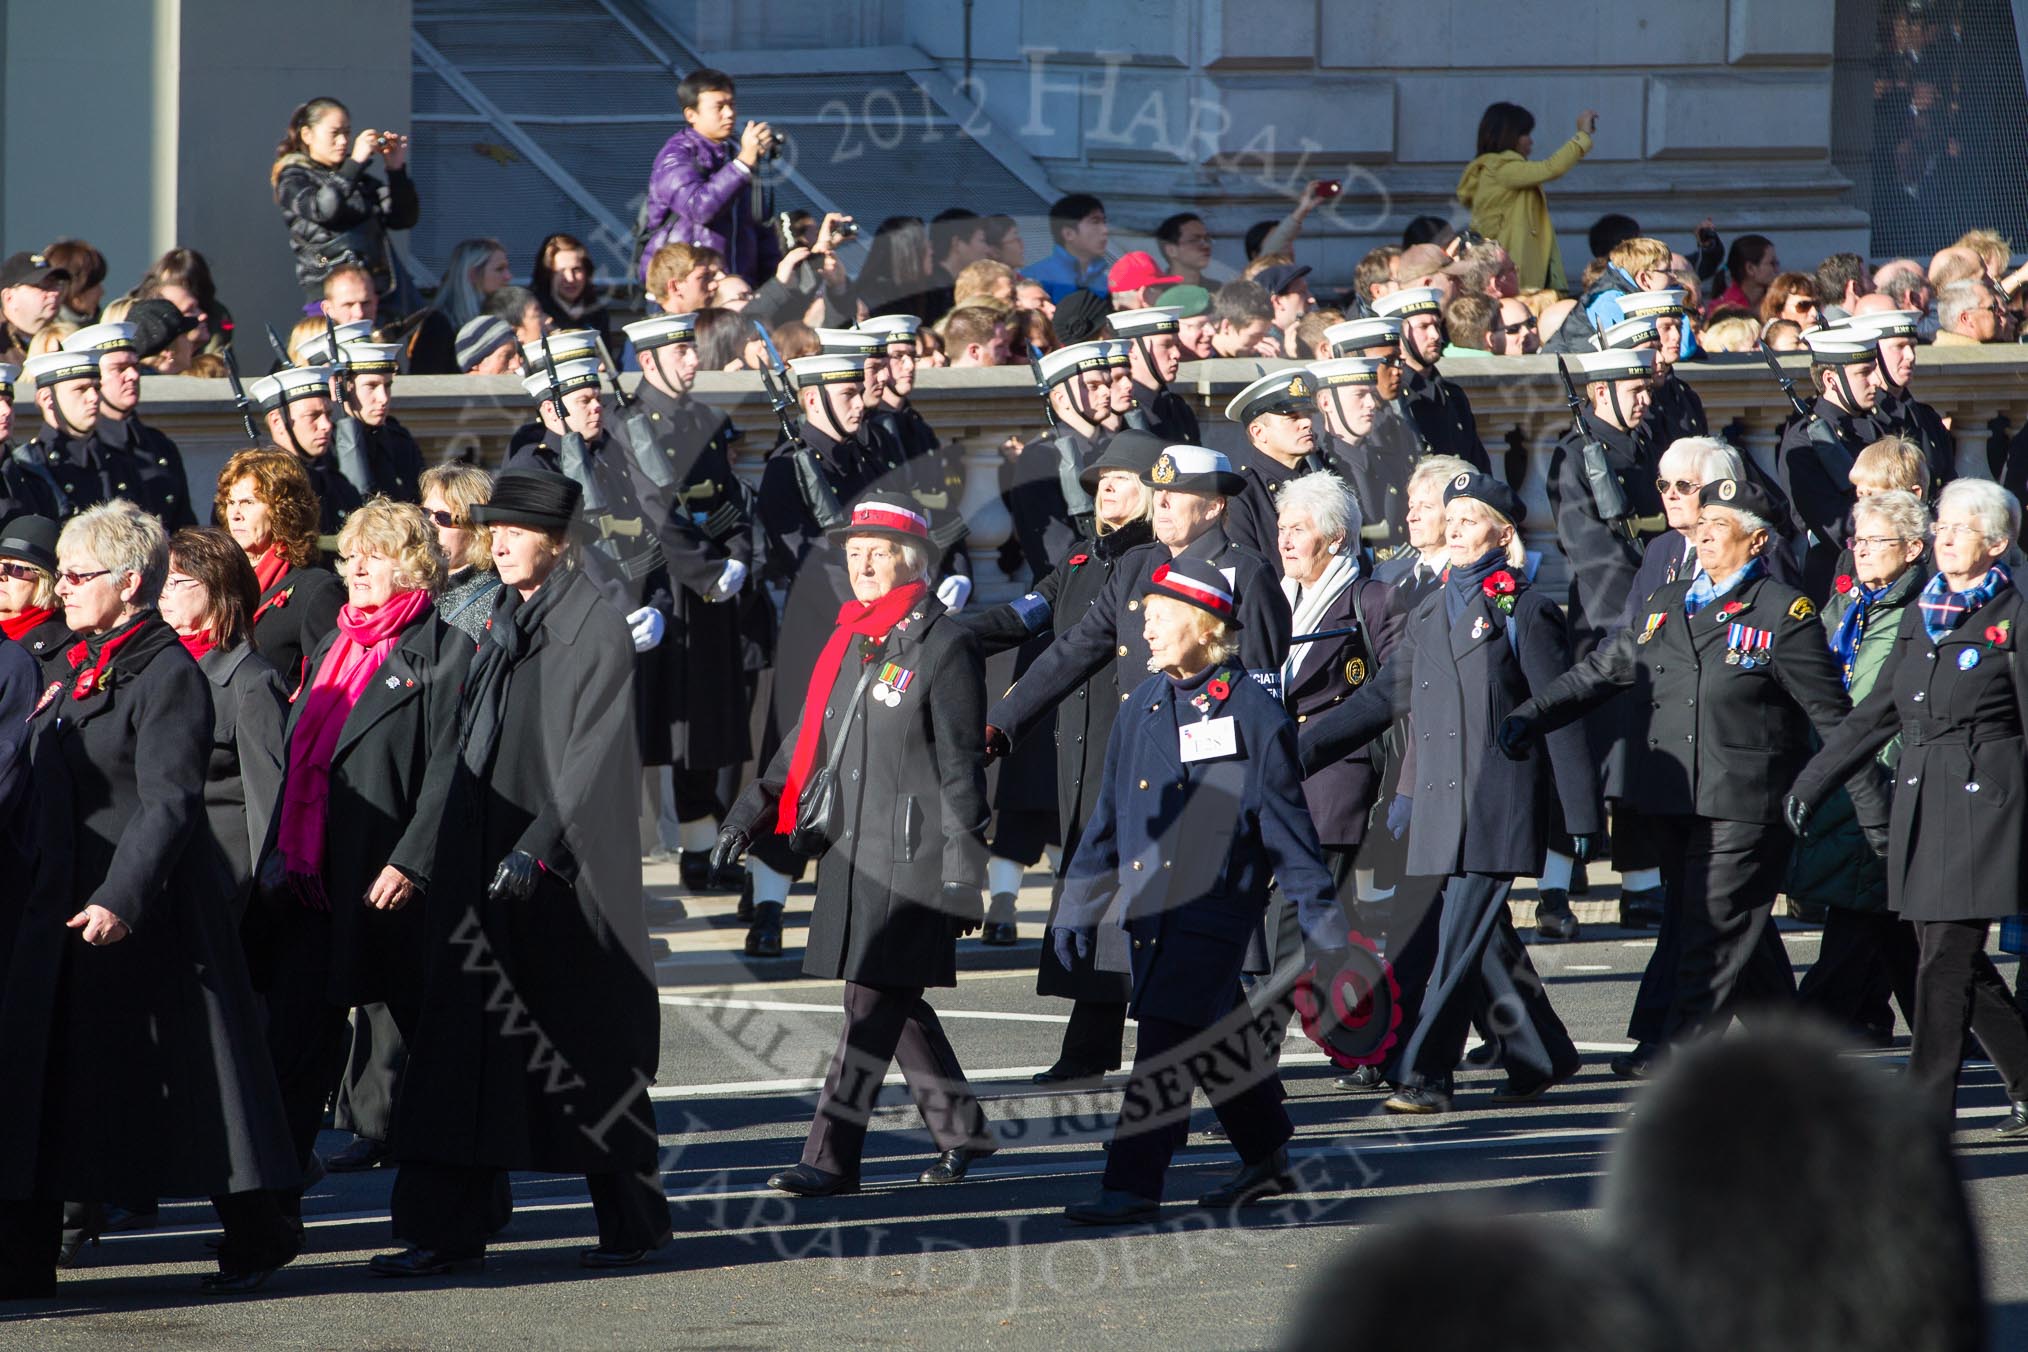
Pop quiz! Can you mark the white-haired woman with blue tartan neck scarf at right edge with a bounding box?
[1785,478,2028,1135]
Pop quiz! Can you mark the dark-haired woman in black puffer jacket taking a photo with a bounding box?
[268,99,422,322]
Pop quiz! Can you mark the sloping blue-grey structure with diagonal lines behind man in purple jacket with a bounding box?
[408,0,1053,284]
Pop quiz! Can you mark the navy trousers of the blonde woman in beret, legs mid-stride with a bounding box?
[1401,874,1578,1084]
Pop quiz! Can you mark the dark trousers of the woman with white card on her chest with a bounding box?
[1105,1001,1296,1202]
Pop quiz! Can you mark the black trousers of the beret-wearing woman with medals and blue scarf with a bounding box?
[1626,817,1795,1046]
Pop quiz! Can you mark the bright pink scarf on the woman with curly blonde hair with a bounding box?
[278,592,430,910]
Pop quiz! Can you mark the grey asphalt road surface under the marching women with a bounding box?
[0,868,2028,1352]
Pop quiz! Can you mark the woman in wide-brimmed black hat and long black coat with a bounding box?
[373,470,669,1277]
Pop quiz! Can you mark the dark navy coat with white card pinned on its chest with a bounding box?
[1057,667,1345,1028]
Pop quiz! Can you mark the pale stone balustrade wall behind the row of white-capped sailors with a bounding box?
[55,345,2028,590]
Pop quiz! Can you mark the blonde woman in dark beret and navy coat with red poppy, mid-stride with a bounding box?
[1304,472,1604,1113]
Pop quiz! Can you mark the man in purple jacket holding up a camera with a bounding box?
[637,69,787,288]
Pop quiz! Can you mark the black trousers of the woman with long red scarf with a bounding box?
[803,981,994,1178]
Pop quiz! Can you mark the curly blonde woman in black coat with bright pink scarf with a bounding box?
[247,499,473,1240]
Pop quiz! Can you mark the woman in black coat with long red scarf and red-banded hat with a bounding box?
[712,493,994,1196]
